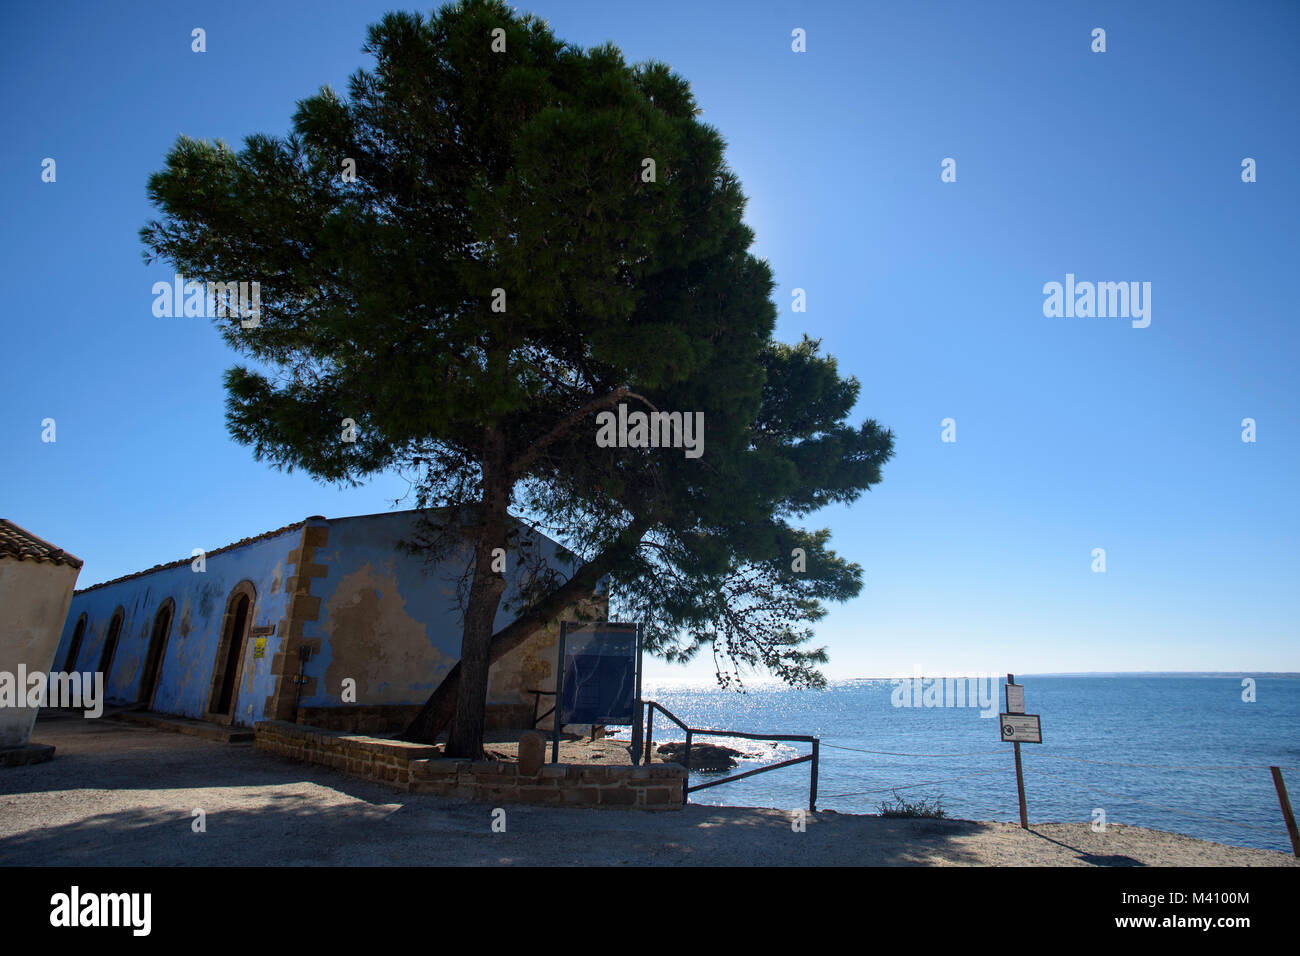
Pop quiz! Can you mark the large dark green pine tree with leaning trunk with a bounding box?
[142,0,892,757]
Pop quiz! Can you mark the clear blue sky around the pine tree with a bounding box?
[0,0,1300,678]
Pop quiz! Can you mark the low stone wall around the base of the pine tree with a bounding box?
[246,721,686,810]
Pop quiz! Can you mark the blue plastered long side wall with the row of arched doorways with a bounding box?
[52,528,302,724]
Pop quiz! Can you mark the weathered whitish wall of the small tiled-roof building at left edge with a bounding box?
[0,557,79,747]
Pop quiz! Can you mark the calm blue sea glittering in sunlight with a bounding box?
[611,674,1300,852]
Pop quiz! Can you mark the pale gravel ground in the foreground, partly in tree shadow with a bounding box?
[0,717,1297,866]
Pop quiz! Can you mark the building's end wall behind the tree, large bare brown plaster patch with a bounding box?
[302,511,573,710]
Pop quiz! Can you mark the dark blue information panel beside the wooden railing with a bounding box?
[559,624,637,724]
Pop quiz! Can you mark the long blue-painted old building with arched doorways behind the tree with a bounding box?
[55,511,601,732]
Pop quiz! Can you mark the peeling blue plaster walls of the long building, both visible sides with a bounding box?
[53,511,598,724]
